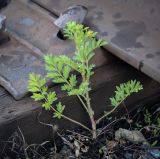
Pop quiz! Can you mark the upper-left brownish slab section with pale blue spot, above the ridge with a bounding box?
[2,0,74,56]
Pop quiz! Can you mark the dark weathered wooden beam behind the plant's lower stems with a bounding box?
[0,62,160,155]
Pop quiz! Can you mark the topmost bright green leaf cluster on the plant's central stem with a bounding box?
[64,22,107,80]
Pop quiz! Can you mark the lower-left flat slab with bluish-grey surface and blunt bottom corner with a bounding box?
[0,38,45,99]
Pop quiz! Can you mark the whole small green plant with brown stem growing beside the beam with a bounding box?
[28,22,142,138]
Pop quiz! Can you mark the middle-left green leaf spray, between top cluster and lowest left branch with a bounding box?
[44,55,77,95]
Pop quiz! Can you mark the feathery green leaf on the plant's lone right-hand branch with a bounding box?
[110,80,143,107]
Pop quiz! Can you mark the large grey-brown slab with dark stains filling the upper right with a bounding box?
[32,0,160,82]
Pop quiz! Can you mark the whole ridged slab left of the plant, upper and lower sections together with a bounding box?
[0,0,113,99]
